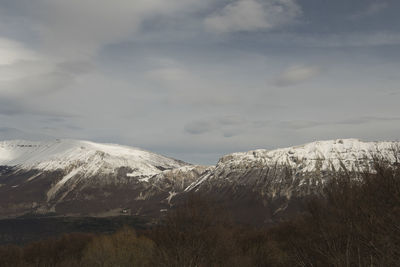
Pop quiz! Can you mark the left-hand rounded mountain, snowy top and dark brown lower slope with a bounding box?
[0,140,206,220]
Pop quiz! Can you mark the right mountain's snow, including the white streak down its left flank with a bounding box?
[185,139,400,191]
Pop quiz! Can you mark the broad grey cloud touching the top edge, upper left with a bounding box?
[0,0,209,59]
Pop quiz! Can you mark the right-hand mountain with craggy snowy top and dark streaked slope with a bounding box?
[185,139,400,223]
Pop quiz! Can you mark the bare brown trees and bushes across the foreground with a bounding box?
[0,161,400,267]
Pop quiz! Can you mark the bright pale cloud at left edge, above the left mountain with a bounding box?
[0,39,93,101]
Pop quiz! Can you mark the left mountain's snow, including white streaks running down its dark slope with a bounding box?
[0,140,188,209]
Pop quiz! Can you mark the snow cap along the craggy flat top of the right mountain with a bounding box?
[218,139,400,172]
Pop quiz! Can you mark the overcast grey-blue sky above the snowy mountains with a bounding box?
[0,0,400,164]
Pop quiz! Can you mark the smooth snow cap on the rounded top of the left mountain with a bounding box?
[0,140,187,176]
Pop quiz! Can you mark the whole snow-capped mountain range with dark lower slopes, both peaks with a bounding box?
[0,139,400,224]
